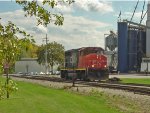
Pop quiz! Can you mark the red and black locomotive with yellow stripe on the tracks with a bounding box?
[61,47,109,80]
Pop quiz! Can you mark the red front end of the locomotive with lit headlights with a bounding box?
[78,47,109,80]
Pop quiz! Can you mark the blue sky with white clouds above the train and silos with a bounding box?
[0,0,147,50]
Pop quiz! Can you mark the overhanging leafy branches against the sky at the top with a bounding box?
[16,0,74,26]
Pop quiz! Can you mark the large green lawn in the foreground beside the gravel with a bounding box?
[0,78,124,113]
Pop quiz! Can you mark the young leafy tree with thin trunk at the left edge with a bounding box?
[0,19,33,98]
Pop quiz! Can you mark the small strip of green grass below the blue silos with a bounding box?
[121,78,150,85]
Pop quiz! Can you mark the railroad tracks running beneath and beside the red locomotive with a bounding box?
[8,75,150,96]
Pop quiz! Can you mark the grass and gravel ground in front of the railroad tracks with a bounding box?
[0,75,150,113]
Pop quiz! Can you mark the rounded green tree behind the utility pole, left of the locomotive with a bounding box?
[37,42,64,72]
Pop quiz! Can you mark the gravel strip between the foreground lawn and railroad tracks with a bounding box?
[11,77,150,113]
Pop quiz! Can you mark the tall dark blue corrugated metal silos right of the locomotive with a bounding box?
[118,20,146,73]
